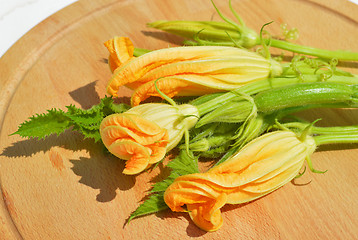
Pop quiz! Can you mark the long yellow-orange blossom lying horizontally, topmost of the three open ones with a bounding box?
[105,37,282,106]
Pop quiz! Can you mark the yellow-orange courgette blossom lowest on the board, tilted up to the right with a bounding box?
[164,131,316,231]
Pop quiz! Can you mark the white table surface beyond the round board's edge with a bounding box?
[0,0,358,57]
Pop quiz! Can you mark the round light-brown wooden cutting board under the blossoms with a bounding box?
[0,0,358,240]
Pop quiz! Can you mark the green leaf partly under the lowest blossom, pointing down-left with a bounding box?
[128,150,199,222]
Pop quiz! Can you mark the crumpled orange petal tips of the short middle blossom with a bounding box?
[100,113,169,174]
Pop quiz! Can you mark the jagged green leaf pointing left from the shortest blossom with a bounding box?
[11,97,129,142]
